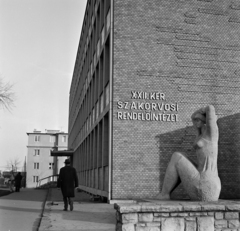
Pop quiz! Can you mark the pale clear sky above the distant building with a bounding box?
[0,0,87,170]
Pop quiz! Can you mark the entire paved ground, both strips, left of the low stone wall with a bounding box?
[0,188,116,231]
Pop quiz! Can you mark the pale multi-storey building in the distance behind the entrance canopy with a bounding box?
[26,130,68,188]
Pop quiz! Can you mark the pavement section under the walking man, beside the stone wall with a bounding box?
[39,188,116,231]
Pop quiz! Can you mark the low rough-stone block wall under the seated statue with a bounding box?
[114,200,240,231]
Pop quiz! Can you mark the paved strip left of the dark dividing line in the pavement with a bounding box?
[0,189,47,231]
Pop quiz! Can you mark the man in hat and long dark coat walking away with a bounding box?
[57,159,78,211]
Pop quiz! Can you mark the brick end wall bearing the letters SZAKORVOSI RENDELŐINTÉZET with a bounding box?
[112,0,240,199]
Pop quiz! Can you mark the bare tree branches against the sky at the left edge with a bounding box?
[0,78,14,110]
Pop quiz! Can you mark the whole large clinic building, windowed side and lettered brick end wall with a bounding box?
[69,0,240,199]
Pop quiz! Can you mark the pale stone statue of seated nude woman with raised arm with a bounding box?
[156,105,221,201]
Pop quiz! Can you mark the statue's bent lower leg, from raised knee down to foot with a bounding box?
[156,152,183,200]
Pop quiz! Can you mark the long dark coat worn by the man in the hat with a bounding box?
[58,166,78,197]
